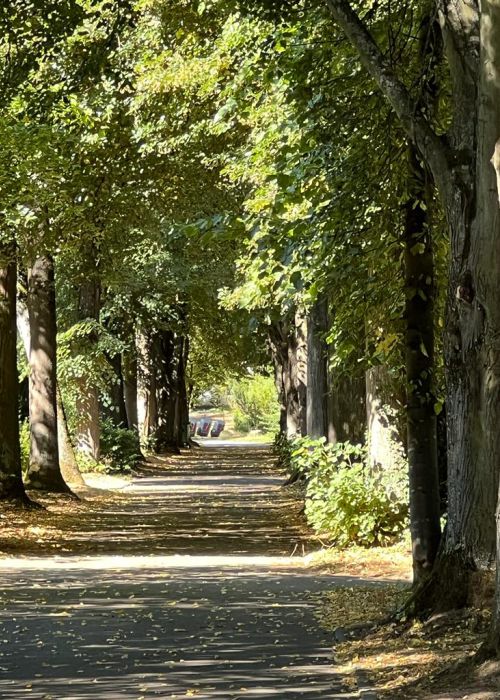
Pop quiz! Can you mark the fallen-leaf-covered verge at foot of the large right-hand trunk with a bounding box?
[317,584,500,700]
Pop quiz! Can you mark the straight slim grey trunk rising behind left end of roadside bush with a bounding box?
[306,298,328,438]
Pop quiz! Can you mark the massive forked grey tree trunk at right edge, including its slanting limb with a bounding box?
[327,0,500,612]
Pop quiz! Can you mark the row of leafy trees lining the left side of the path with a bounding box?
[0,1,266,503]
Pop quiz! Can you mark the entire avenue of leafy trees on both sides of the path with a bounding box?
[0,0,500,646]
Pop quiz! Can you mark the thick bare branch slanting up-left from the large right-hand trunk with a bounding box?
[326,0,451,194]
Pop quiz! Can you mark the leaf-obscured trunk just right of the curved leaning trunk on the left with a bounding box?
[75,278,101,461]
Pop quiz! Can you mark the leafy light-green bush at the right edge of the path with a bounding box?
[290,438,408,547]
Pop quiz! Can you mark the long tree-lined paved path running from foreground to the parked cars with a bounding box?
[0,447,372,700]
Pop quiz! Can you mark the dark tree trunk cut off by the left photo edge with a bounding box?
[0,249,28,502]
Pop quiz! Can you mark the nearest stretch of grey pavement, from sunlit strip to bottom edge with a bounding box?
[0,568,356,698]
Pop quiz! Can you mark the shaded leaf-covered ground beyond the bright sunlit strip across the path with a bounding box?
[0,447,310,556]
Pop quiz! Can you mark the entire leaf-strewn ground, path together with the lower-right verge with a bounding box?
[0,442,500,700]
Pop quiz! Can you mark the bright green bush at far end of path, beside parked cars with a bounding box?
[229,374,280,433]
